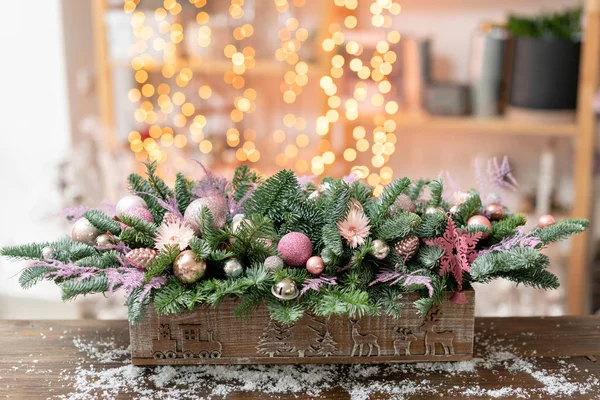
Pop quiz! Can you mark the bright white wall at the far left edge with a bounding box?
[0,0,77,312]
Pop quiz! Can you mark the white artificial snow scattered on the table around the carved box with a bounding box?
[3,328,600,400]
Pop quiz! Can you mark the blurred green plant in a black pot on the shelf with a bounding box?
[507,8,582,110]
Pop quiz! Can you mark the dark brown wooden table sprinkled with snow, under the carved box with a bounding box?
[0,316,600,399]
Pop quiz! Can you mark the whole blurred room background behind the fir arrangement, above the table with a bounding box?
[0,0,600,319]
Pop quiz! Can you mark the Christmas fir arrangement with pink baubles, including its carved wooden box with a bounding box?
[0,163,587,365]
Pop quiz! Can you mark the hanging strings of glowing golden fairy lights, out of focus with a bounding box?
[124,0,401,195]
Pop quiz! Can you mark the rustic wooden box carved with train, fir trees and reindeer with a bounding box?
[130,291,475,365]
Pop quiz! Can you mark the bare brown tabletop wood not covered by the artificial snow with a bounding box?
[0,316,600,399]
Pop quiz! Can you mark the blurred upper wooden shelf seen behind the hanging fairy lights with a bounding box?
[109,60,323,75]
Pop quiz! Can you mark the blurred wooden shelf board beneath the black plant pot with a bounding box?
[359,113,579,137]
